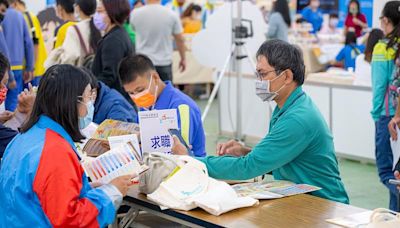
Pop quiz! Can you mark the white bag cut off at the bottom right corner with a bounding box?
[366,208,400,228]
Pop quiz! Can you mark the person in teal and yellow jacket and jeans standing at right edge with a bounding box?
[371,1,400,211]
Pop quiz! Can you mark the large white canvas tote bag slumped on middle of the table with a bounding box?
[147,156,258,216]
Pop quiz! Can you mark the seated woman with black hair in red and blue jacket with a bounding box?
[0,65,133,227]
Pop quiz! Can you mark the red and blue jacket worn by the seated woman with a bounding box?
[0,116,116,227]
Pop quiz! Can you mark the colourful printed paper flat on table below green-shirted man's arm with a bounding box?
[232,181,321,199]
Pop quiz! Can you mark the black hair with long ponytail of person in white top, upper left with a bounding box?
[75,0,101,53]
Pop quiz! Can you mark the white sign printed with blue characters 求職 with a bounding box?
[139,109,178,153]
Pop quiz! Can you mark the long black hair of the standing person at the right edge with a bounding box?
[381,1,400,58]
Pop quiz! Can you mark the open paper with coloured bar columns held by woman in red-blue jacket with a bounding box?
[83,143,147,184]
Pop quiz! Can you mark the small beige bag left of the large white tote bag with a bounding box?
[139,152,178,194]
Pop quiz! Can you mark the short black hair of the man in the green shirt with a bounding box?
[257,40,305,85]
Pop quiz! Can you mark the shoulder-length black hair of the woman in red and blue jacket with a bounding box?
[21,64,90,142]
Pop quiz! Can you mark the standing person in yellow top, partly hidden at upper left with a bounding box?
[15,0,47,86]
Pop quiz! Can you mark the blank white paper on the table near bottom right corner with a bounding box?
[326,211,373,228]
